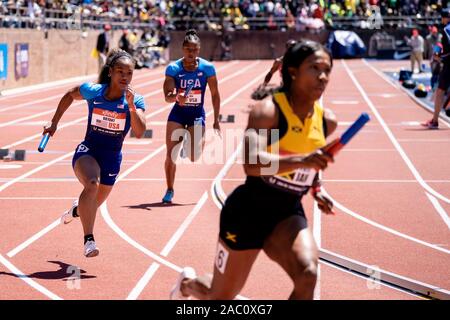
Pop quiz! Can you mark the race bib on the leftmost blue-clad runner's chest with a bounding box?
[91,108,127,135]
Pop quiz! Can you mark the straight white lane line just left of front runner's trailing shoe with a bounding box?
[127,191,208,300]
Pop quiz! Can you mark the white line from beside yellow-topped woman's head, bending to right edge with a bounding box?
[342,60,450,208]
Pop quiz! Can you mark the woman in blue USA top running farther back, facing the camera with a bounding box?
[162,30,220,203]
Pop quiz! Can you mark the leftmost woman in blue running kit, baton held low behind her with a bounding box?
[44,49,146,257]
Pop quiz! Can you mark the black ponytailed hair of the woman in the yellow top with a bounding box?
[251,40,333,100]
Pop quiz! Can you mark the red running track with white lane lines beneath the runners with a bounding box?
[0,60,450,299]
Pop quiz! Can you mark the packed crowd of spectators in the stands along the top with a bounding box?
[0,0,447,30]
